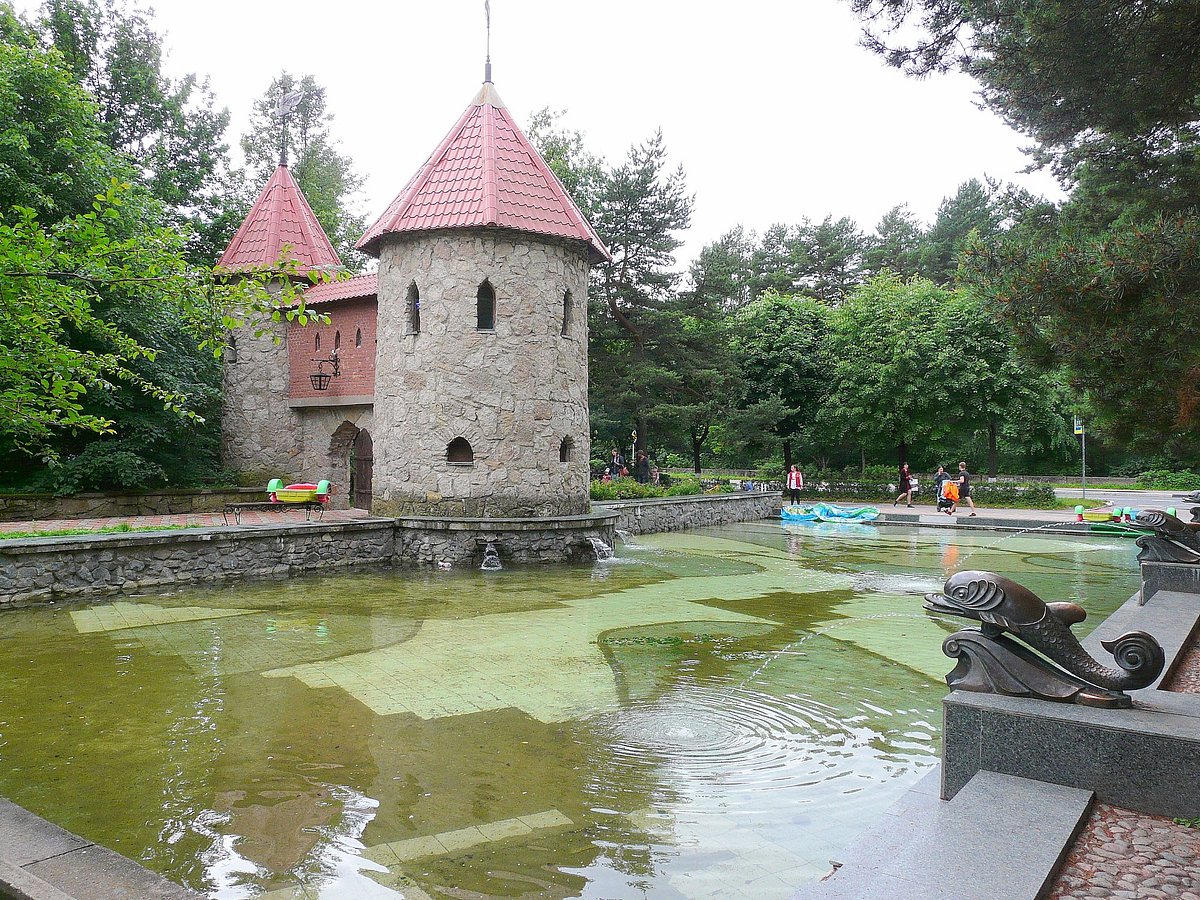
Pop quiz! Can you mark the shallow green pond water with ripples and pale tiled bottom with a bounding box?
[0,522,1138,900]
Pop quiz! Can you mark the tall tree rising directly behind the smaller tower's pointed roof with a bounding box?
[241,72,366,271]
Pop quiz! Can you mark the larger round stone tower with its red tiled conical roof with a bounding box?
[358,77,608,518]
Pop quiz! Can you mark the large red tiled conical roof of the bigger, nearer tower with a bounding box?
[356,82,612,262]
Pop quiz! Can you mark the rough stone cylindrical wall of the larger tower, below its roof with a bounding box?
[372,229,590,517]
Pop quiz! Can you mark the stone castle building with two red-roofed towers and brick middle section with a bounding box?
[220,78,608,518]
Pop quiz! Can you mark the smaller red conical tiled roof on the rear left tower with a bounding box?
[217,166,342,275]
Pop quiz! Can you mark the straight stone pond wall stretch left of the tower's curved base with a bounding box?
[0,521,396,608]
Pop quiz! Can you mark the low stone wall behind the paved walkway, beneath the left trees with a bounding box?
[0,487,264,522]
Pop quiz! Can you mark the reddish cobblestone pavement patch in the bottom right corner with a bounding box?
[1050,803,1200,900]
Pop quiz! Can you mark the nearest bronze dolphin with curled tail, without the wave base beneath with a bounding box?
[925,571,1166,691]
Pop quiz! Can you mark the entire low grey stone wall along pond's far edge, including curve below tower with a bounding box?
[0,493,779,608]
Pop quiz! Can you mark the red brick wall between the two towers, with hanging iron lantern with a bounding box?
[288,298,377,400]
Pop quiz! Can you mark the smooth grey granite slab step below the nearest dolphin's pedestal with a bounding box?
[792,769,1092,900]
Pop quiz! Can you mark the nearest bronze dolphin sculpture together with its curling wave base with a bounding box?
[925,571,1165,707]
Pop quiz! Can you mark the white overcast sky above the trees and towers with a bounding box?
[19,0,1057,268]
